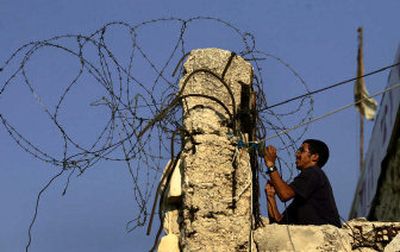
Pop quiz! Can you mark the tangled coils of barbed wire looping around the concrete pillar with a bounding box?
[0,17,313,250]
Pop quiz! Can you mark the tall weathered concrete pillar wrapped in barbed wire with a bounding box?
[180,49,252,251]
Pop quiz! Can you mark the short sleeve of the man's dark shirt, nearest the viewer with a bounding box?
[289,167,322,199]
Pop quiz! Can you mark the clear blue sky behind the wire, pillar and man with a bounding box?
[0,0,400,252]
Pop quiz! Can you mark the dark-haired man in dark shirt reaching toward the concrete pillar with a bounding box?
[264,139,341,227]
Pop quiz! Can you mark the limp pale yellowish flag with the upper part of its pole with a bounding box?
[354,27,378,120]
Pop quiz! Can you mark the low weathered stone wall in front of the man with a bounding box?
[255,220,400,252]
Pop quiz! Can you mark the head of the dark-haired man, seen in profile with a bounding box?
[296,139,329,170]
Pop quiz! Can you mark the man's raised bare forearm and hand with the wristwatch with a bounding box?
[264,145,296,202]
